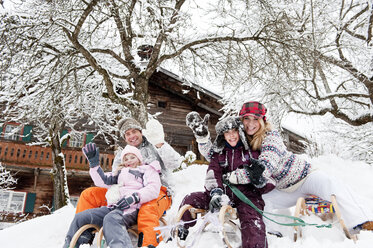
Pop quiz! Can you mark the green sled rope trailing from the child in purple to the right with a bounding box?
[225,182,332,228]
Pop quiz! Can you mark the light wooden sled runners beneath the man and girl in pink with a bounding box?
[69,217,166,248]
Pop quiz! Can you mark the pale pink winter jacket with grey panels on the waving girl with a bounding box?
[89,161,161,212]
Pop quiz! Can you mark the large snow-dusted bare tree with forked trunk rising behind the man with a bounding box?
[10,0,308,124]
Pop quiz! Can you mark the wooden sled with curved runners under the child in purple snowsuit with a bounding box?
[173,205,241,248]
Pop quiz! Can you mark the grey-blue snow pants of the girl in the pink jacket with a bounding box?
[63,207,138,248]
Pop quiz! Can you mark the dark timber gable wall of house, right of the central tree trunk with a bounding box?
[148,71,221,160]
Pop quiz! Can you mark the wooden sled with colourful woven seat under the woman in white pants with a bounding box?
[294,195,357,242]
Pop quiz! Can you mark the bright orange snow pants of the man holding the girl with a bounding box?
[76,186,171,247]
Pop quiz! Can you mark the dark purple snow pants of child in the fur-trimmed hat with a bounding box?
[180,192,268,248]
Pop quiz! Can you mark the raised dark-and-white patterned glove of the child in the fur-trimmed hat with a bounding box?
[186,111,210,143]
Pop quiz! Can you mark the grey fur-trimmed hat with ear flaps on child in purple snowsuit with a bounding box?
[212,116,249,152]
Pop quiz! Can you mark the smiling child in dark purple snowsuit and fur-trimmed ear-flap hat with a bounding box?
[177,117,274,248]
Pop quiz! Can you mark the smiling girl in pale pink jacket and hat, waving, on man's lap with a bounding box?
[63,143,161,248]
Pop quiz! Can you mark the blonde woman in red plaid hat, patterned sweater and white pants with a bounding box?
[229,101,373,235]
